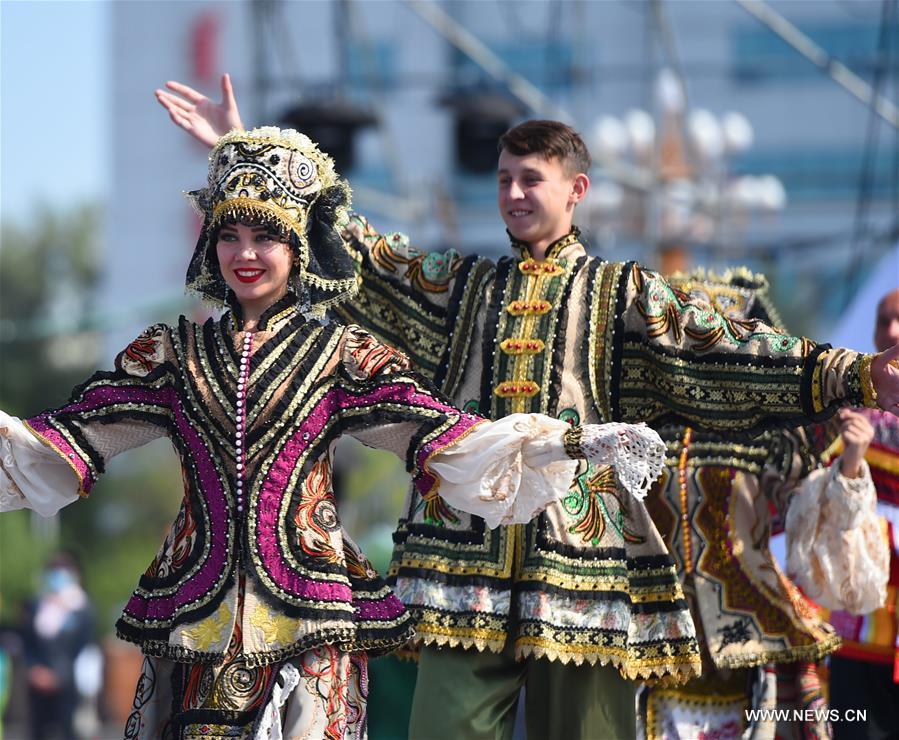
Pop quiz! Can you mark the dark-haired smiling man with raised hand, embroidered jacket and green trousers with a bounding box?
[157,83,899,740]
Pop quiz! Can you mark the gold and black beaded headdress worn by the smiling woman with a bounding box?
[186,126,358,315]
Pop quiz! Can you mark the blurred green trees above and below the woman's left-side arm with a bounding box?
[0,206,183,632]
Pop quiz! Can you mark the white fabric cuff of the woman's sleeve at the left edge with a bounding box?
[0,411,79,516]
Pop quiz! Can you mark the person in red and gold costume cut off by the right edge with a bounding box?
[818,289,899,740]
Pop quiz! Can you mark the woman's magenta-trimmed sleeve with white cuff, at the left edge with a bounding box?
[0,324,177,516]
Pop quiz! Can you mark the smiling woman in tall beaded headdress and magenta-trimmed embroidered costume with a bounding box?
[0,128,663,738]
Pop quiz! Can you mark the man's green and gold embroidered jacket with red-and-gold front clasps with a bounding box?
[339,216,876,677]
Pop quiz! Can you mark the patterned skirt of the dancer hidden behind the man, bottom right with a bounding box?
[637,662,832,740]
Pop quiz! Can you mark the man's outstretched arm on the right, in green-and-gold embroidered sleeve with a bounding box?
[590,264,899,432]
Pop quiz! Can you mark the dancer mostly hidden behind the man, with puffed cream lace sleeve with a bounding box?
[638,269,888,738]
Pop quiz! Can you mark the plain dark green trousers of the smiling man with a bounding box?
[409,644,636,740]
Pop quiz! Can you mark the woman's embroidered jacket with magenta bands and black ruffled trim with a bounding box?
[14,297,480,666]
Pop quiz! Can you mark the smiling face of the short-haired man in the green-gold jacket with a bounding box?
[497,149,587,247]
